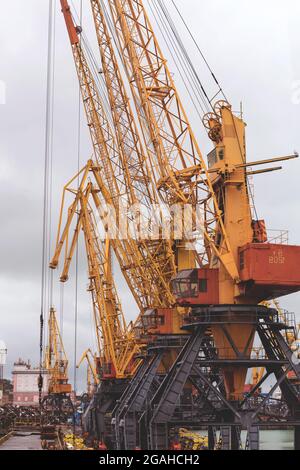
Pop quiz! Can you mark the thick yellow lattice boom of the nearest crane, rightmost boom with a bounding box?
[108,0,239,283]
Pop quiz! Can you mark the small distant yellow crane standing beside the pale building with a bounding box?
[44,308,72,395]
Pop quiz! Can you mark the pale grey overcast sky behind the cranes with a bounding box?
[0,0,300,386]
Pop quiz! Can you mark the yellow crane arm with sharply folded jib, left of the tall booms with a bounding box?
[50,167,140,379]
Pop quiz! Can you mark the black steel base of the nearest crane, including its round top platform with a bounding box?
[109,306,300,450]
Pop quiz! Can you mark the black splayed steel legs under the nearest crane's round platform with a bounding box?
[123,307,300,450]
